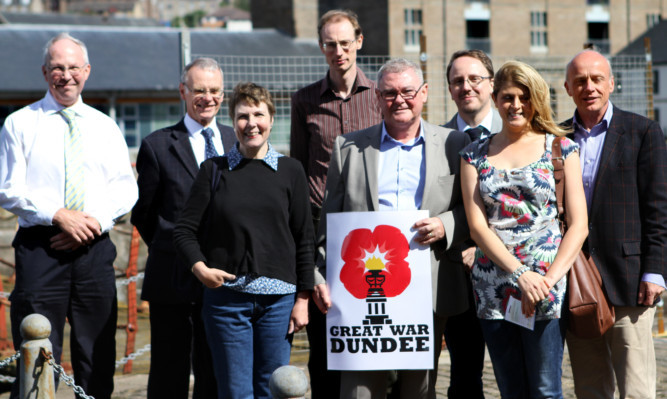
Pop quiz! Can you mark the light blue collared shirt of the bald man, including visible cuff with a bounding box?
[573,101,665,287]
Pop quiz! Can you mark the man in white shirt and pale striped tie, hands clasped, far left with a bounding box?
[0,33,137,399]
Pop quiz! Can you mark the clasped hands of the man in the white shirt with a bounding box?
[51,208,102,251]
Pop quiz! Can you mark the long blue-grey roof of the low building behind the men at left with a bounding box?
[0,25,320,92]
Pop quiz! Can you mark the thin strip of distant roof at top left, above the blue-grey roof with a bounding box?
[0,12,162,27]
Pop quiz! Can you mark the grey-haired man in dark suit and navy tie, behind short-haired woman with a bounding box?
[131,58,236,399]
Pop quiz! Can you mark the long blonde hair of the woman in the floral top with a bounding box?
[493,61,569,136]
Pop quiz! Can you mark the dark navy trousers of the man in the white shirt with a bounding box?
[10,226,118,399]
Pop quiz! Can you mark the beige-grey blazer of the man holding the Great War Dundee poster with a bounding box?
[315,120,470,316]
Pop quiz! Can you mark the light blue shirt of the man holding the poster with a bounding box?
[378,122,426,211]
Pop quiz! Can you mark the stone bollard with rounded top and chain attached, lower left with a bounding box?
[19,313,56,399]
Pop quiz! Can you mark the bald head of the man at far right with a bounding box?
[565,50,614,129]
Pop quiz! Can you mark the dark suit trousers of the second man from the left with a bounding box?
[147,302,217,399]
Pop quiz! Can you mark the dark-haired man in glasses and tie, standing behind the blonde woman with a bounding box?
[444,50,503,399]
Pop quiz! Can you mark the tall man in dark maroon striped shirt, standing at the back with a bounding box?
[290,10,381,399]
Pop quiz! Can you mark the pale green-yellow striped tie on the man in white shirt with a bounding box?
[60,108,83,211]
